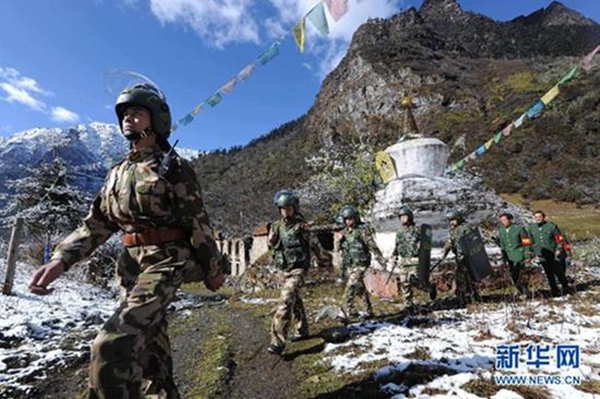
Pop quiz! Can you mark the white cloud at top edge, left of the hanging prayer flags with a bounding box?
[148,0,259,48]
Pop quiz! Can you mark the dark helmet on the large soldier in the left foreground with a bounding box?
[115,83,171,138]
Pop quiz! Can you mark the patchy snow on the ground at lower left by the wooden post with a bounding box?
[0,261,117,397]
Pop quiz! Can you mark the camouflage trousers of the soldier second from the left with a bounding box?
[271,269,308,347]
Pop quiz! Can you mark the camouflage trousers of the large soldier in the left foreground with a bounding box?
[89,243,191,399]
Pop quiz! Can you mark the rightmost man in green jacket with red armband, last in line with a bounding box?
[528,211,572,296]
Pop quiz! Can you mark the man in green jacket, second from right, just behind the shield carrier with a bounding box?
[498,212,533,295]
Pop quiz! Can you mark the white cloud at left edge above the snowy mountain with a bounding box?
[0,66,79,123]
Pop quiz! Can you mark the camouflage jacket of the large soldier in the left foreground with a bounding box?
[52,145,220,277]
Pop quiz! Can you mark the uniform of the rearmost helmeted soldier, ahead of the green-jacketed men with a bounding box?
[442,224,480,304]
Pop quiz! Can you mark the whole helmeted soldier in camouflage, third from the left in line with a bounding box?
[340,205,385,322]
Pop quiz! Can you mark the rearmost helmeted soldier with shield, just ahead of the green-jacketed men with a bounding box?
[440,210,481,306]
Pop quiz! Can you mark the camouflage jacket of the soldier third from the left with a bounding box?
[340,224,383,268]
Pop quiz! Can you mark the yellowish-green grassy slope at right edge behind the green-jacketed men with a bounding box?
[501,194,600,241]
